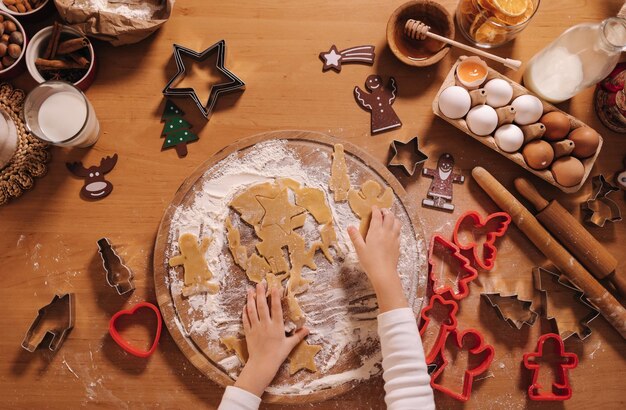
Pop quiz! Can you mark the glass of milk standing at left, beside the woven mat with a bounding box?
[24,81,100,147]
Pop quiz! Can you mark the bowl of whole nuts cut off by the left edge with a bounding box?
[0,11,26,78]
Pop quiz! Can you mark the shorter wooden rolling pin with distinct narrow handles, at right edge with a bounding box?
[515,178,626,295]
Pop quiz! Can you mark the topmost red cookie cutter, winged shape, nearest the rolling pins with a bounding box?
[452,211,511,271]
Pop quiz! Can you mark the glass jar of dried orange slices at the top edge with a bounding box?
[456,0,540,48]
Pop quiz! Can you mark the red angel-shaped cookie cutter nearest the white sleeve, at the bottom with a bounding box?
[430,329,495,401]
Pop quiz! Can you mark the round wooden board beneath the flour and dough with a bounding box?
[154,131,427,404]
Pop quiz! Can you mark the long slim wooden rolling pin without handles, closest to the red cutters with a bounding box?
[472,167,626,339]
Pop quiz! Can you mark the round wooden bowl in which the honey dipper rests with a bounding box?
[387,0,454,67]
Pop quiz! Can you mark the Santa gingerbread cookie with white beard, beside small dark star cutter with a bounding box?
[422,154,465,212]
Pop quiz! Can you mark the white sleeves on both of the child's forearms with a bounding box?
[218,308,435,410]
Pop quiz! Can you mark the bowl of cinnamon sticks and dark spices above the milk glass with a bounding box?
[26,22,96,91]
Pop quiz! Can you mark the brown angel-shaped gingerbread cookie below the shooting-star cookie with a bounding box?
[354,75,402,134]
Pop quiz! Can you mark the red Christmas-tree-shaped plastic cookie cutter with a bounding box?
[428,234,478,300]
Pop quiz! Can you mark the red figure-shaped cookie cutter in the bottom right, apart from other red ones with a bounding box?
[524,333,578,401]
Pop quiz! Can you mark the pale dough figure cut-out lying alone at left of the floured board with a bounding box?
[169,233,220,297]
